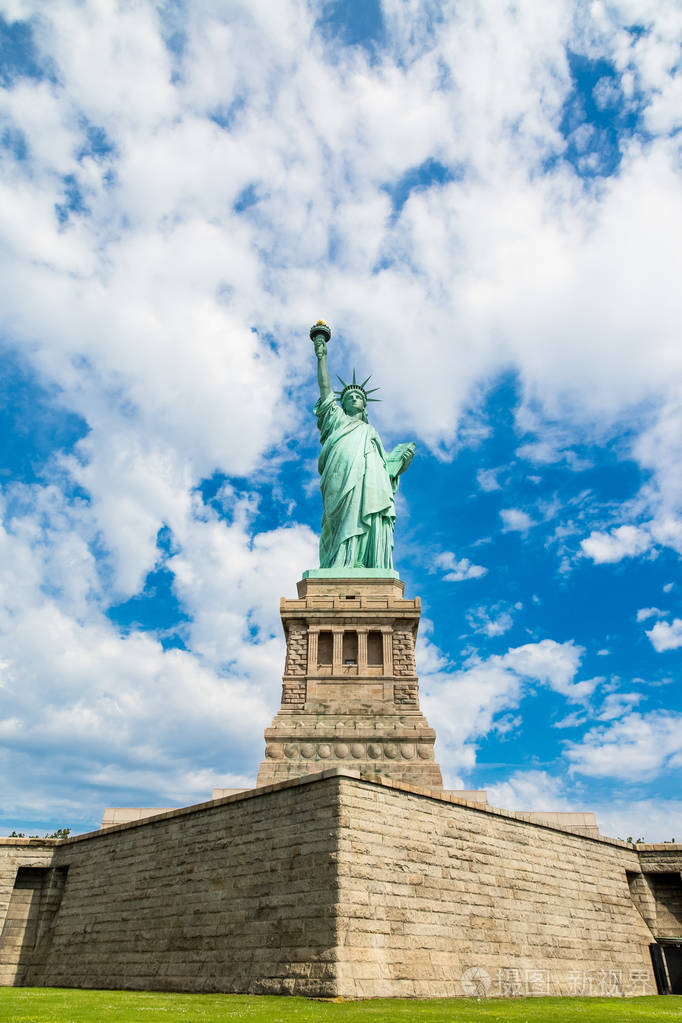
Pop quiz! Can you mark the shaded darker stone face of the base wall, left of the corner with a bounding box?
[11,783,337,995]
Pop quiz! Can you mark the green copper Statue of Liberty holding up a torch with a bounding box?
[310,320,414,569]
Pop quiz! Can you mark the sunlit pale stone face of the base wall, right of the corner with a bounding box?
[337,779,656,997]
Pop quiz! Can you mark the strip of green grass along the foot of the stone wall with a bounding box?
[0,987,682,1023]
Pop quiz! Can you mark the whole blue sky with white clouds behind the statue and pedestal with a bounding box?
[0,0,682,841]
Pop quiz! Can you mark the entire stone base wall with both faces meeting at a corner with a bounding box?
[0,770,682,998]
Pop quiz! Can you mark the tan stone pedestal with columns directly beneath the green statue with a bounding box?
[257,570,443,790]
